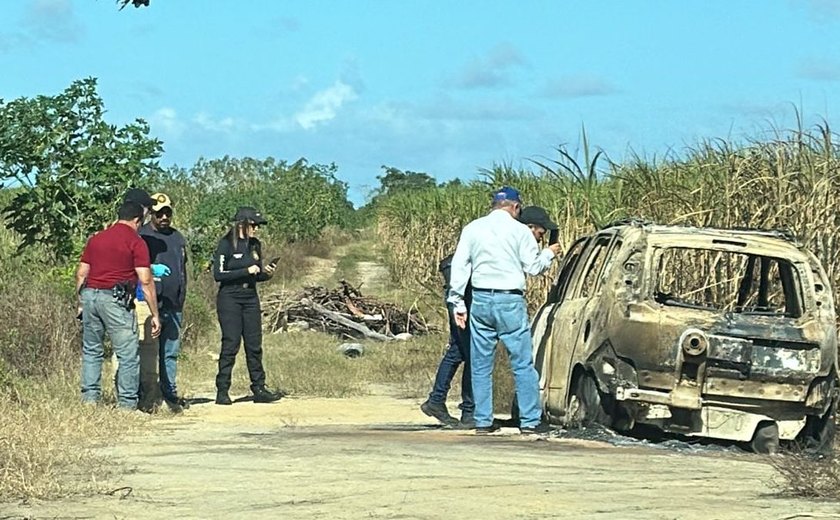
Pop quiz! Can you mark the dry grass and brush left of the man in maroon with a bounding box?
[0,225,148,500]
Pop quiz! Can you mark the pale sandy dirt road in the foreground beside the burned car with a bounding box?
[0,396,840,519]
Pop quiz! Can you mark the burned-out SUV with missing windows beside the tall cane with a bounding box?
[533,221,838,452]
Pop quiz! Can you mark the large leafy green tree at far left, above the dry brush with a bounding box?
[0,78,163,258]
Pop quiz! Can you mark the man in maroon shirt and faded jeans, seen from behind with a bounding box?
[76,202,160,410]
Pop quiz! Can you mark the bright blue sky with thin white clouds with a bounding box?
[0,0,840,204]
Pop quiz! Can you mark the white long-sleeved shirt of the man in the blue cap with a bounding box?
[448,209,554,313]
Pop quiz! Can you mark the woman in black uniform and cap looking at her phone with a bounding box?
[213,206,283,405]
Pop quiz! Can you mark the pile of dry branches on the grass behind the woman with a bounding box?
[262,280,430,341]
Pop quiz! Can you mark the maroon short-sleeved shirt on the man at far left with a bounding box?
[81,222,149,289]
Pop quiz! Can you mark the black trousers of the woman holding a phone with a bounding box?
[216,286,265,392]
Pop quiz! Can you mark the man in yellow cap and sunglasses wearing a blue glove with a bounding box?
[138,193,187,413]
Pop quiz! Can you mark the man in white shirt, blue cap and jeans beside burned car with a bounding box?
[448,186,560,434]
